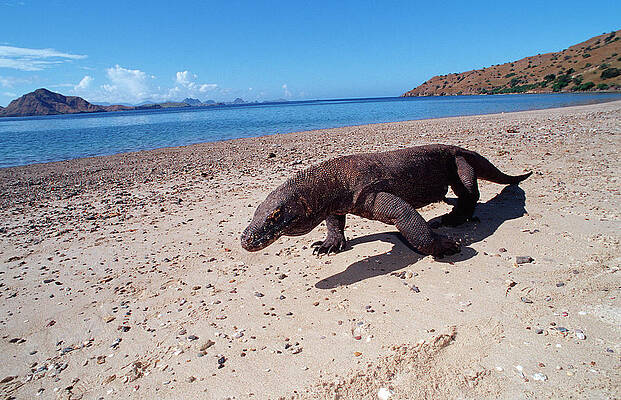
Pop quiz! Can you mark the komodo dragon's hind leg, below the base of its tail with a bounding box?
[442,156,479,226]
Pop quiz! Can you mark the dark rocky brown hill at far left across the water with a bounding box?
[0,89,132,117]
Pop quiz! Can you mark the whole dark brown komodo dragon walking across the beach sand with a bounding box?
[241,144,532,257]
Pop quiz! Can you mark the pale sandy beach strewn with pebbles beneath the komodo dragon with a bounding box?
[0,101,621,399]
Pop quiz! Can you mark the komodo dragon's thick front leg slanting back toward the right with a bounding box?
[364,192,460,257]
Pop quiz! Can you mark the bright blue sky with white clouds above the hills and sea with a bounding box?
[0,0,621,106]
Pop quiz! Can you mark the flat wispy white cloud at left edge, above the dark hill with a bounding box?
[0,46,87,71]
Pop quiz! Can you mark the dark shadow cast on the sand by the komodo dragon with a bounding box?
[315,185,526,289]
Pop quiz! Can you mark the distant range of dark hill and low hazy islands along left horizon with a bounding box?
[0,88,294,117]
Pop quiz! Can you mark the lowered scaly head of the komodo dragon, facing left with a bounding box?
[241,186,312,251]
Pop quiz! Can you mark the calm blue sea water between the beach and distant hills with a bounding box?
[0,93,621,167]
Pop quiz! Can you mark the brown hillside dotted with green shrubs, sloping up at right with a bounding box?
[402,30,621,97]
